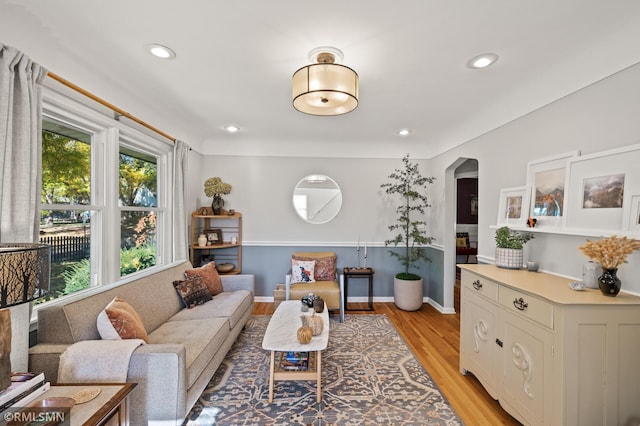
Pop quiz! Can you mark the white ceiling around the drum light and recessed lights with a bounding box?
[0,0,640,158]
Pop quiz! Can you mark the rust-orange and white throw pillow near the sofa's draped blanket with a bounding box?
[97,296,148,342]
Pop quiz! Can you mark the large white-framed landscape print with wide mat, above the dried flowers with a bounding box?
[566,145,640,233]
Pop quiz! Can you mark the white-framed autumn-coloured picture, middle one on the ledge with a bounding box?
[527,151,580,227]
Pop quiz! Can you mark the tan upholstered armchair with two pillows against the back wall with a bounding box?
[285,252,344,322]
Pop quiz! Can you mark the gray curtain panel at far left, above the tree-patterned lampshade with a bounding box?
[0,43,47,243]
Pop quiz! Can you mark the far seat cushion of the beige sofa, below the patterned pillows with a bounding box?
[169,290,253,328]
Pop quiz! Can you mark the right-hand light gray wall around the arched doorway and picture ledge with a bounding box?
[428,61,640,293]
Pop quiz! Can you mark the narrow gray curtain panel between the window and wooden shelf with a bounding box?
[172,140,189,261]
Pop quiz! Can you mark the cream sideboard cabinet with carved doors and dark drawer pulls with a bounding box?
[459,264,640,426]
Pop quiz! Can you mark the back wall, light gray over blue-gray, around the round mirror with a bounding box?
[188,155,440,300]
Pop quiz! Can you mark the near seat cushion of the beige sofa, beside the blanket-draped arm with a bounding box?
[149,316,230,389]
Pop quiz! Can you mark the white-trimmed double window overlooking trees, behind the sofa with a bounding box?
[39,85,173,303]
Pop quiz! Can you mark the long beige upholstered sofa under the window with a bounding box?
[29,262,255,425]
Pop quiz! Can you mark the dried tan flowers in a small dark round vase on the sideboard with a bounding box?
[578,235,640,297]
